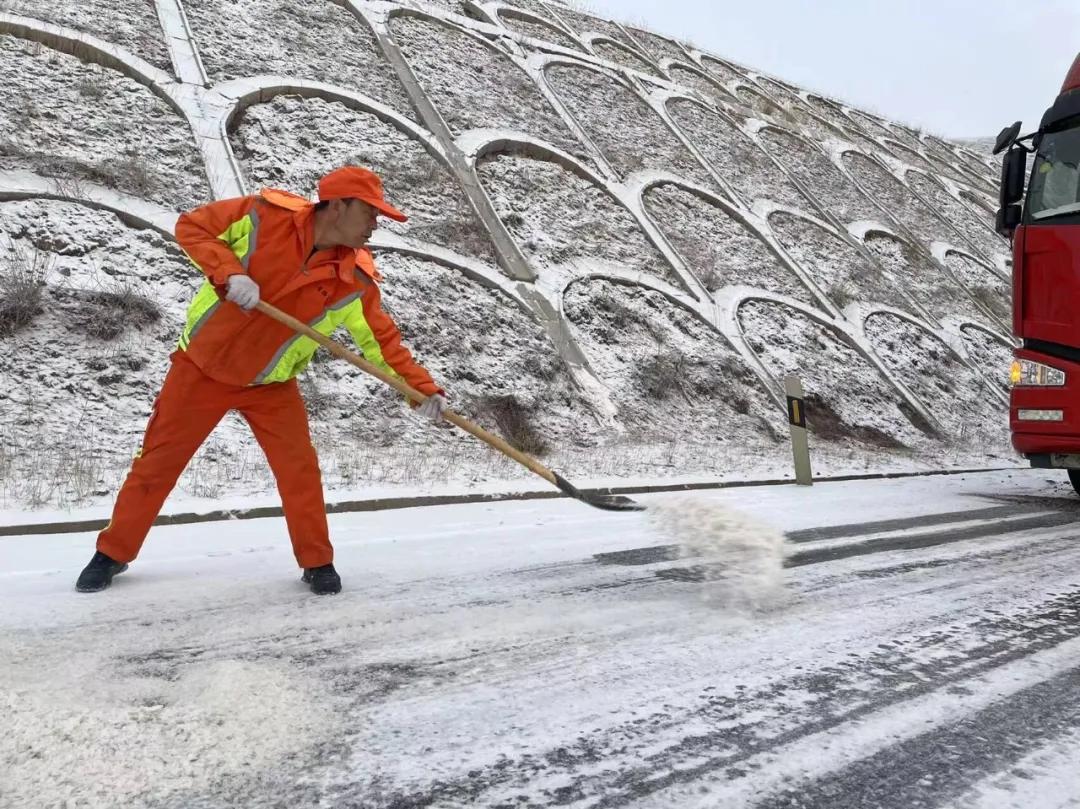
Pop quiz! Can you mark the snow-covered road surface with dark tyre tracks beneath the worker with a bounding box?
[0,470,1080,809]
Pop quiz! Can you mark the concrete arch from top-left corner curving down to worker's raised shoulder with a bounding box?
[0,12,222,197]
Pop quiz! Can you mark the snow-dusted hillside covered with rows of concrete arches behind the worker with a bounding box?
[0,0,1014,505]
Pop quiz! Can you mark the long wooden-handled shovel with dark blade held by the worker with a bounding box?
[255,300,645,511]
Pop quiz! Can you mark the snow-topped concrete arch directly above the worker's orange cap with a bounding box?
[207,76,454,193]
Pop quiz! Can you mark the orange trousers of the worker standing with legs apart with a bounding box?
[97,351,334,567]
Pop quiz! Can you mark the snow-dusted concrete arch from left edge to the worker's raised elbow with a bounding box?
[0,172,178,240]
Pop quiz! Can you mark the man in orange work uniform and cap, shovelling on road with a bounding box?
[76,166,446,594]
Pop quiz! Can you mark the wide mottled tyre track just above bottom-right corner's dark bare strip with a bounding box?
[360,586,1080,809]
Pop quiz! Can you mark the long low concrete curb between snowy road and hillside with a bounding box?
[0,467,1025,537]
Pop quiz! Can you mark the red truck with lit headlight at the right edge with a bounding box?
[994,55,1080,494]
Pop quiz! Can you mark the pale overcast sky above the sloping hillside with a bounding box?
[582,0,1080,137]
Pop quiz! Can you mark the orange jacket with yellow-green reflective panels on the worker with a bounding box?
[176,189,443,395]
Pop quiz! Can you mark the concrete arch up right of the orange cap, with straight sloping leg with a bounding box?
[465,135,708,300]
